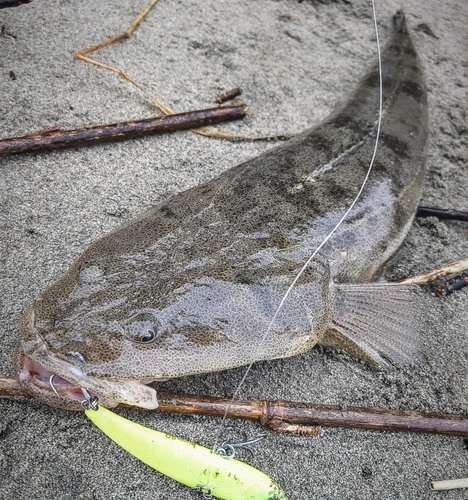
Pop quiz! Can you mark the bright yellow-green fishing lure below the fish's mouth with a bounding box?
[85,407,286,500]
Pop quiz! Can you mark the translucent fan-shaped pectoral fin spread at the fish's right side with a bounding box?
[319,283,422,369]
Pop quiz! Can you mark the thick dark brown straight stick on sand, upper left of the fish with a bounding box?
[0,104,248,156]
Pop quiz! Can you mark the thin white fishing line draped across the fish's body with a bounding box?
[213,0,383,450]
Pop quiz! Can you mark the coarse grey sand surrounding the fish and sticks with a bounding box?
[0,0,468,500]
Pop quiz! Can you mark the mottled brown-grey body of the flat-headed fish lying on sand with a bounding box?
[17,12,427,408]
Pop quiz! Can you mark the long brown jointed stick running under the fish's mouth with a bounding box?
[0,378,468,436]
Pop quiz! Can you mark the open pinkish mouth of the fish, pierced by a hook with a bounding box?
[18,355,158,409]
